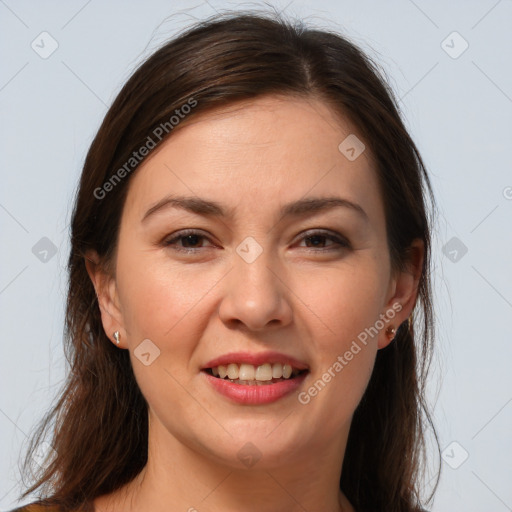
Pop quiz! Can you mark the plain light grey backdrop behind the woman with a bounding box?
[0,0,512,512]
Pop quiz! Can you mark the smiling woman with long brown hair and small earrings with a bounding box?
[15,9,435,512]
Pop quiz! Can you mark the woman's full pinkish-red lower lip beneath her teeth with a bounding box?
[201,372,308,405]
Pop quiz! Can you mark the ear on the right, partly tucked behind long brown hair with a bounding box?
[378,238,425,349]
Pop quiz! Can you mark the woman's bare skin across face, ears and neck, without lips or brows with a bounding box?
[87,96,423,512]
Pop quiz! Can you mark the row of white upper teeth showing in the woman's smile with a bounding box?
[211,363,300,385]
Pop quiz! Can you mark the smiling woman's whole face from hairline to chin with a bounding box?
[89,96,413,467]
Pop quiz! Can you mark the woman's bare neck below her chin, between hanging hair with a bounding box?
[94,412,353,512]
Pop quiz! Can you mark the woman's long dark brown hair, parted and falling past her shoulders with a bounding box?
[22,12,439,512]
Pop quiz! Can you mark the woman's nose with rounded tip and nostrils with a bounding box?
[219,247,293,331]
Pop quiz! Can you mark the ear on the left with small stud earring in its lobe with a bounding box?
[85,250,126,348]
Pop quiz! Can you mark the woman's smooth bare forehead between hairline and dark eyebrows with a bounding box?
[121,96,382,226]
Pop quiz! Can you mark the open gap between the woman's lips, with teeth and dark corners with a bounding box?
[201,362,309,386]
